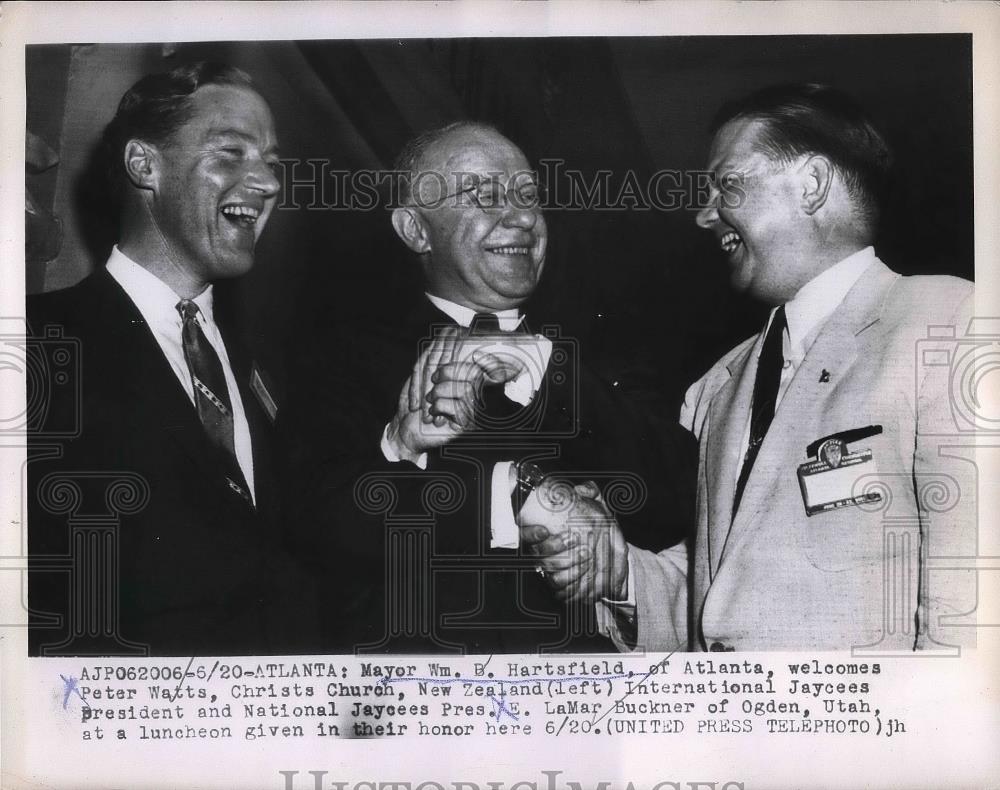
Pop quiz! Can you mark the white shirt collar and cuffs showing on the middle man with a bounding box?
[381,294,552,549]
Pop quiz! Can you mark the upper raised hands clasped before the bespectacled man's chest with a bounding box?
[386,327,522,462]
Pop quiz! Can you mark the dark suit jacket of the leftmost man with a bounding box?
[27,269,309,655]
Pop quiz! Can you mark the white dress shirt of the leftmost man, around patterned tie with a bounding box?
[107,246,257,502]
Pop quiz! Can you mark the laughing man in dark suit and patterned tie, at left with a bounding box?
[28,63,305,655]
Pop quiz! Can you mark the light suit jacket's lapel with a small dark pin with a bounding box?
[727,260,899,564]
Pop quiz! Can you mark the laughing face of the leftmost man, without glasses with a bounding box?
[149,84,280,284]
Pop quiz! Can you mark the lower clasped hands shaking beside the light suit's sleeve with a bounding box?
[518,480,628,603]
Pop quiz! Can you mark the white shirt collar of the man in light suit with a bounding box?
[765,247,876,353]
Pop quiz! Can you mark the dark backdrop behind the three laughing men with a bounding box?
[27,35,973,409]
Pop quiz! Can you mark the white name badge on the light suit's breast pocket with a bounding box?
[798,425,882,516]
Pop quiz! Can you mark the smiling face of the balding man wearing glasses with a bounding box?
[414,127,548,311]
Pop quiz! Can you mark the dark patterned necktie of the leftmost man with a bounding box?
[177,299,251,502]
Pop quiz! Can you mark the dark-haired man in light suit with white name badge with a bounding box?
[520,85,976,651]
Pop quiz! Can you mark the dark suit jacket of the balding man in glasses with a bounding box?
[278,298,695,653]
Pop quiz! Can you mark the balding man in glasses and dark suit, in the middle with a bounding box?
[282,123,693,653]
